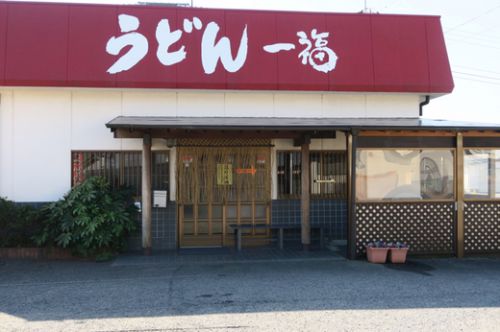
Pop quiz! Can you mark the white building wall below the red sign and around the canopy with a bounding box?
[0,88,419,202]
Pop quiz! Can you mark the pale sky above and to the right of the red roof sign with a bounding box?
[9,0,500,123]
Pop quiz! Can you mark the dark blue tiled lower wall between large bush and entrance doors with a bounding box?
[128,202,177,251]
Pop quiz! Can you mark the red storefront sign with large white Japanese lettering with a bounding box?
[0,2,453,93]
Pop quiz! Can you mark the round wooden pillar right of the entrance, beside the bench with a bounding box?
[300,137,311,250]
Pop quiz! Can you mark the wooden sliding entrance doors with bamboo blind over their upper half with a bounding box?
[176,144,272,248]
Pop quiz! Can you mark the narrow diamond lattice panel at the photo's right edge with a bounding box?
[464,202,500,254]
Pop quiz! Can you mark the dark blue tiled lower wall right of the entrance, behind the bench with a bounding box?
[271,199,347,240]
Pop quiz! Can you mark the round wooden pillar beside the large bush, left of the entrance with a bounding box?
[141,134,153,255]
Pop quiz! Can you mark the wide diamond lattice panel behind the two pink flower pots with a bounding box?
[356,203,455,256]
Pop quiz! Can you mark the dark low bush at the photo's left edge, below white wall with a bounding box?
[0,198,43,247]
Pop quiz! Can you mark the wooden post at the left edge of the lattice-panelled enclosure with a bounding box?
[347,133,357,259]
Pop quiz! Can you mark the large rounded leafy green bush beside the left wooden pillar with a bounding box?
[35,177,136,256]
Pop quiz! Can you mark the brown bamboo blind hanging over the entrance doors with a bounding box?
[177,140,271,204]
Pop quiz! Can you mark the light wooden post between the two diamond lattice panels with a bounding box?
[455,133,464,258]
